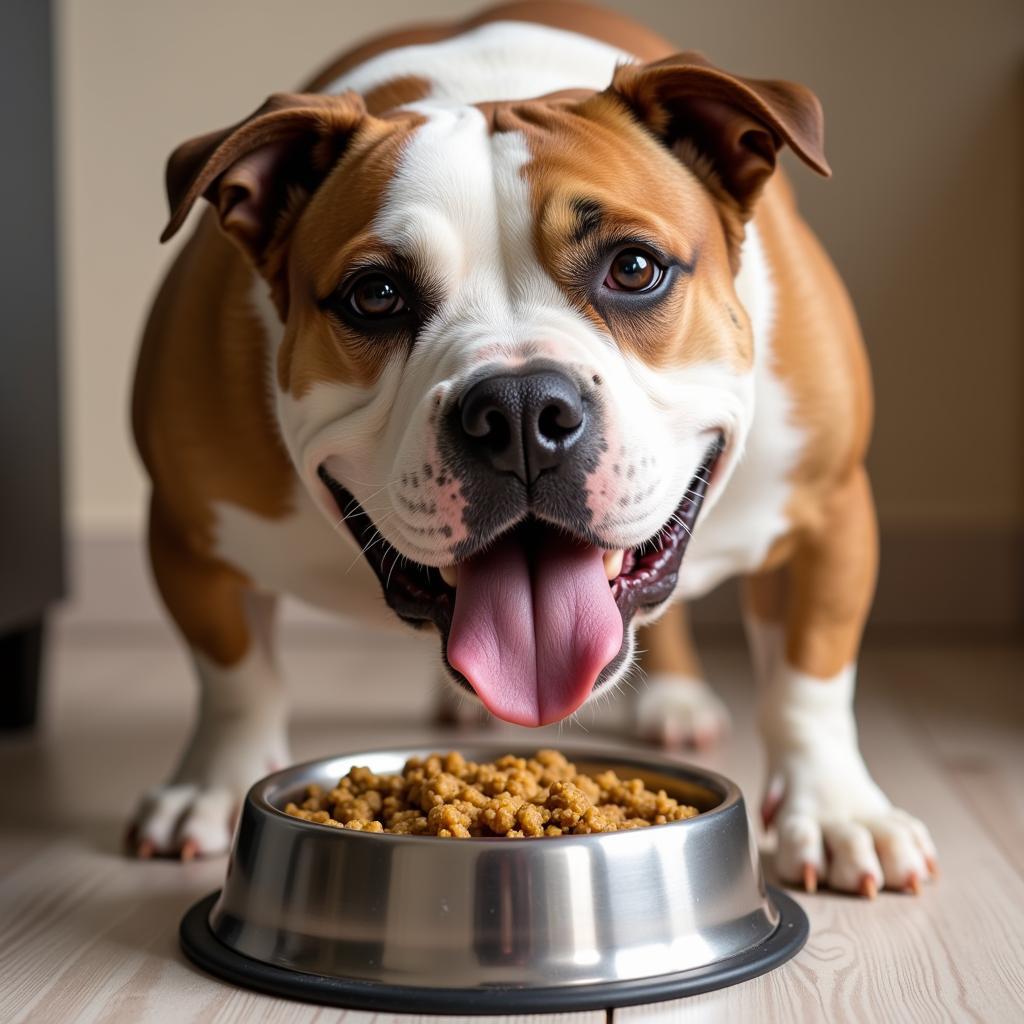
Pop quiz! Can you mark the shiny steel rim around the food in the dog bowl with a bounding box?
[245,739,743,849]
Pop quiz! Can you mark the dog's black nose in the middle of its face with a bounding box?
[460,370,587,485]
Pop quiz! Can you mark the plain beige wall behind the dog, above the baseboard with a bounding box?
[58,0,1024,534]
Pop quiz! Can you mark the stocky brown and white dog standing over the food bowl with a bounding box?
[134,2,935,895]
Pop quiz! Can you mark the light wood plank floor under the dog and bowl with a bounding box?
[0,618,1024,1024]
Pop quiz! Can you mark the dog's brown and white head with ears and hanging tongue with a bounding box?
[165,54,827,725]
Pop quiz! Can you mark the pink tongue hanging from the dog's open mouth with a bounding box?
[447,529,623,726]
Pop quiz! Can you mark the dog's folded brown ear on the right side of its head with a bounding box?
[607,52,831,217]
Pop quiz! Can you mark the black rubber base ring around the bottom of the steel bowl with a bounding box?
[179,886,808,1014]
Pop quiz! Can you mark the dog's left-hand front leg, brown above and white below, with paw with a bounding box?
[129,509,289,859]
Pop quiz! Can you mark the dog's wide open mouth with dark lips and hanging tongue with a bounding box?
[317,436,724,726]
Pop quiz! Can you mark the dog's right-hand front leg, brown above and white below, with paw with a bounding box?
[746,469,936,896]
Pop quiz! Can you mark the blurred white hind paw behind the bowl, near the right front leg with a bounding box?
[636,673,729,751]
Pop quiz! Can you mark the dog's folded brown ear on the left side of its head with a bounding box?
[160,92,368,266]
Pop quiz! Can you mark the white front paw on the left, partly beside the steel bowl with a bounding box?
[127,728,290,860]
